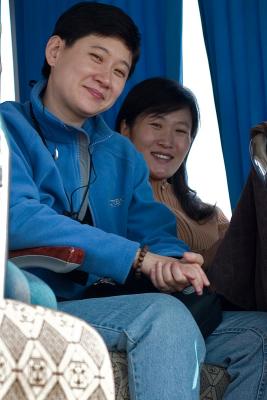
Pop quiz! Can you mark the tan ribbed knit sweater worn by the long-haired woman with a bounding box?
[150,179,229,267]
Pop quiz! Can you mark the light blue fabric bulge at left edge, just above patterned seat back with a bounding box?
[5,261,57,309]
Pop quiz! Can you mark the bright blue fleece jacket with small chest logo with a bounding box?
[0,82,188,299]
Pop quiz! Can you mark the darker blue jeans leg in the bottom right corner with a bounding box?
[206,311,267,400]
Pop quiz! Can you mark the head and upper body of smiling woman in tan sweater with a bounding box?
[116,78,229,267]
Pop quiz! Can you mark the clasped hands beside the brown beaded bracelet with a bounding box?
[142,252,210,295]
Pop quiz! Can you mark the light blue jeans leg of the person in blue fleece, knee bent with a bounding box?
[58,293,205,400]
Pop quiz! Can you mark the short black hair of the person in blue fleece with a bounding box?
[42,1,141,79]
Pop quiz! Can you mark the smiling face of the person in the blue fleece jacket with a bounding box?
[43,35,132,126]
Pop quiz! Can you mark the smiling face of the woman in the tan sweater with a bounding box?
[121,108,192,180]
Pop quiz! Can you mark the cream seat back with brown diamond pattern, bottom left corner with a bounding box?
[0,300,115,400]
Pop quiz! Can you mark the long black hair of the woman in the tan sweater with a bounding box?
[116,77,215,221]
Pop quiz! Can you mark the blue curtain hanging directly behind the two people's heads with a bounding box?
[12,0,182,126]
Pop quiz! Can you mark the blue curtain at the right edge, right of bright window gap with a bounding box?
[199,0,267,208]
